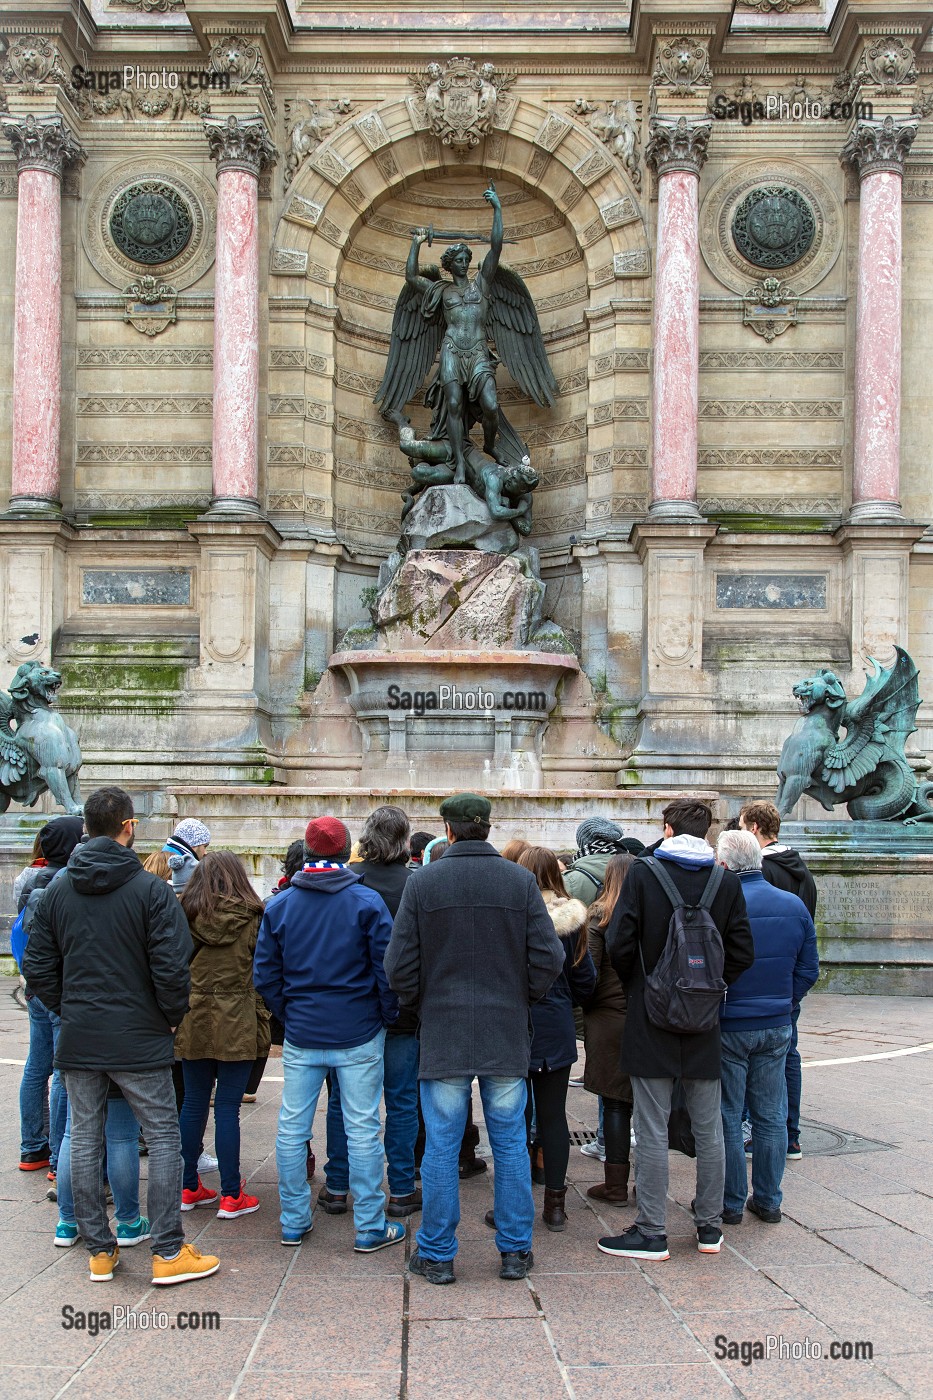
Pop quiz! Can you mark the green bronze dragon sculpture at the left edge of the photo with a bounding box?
[0,661,83,816]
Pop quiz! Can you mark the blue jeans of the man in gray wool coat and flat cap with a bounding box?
[417,1075,535,1260]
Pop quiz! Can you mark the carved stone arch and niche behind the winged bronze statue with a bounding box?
[269,99,649,540]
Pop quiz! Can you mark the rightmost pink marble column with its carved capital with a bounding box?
[842,116,919,521]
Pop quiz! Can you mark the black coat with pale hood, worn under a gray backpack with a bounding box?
[605,836,755,1079]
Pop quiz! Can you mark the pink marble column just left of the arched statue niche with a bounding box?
[205,116,275,515]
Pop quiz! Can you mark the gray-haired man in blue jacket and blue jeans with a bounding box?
[716,832,820,1225]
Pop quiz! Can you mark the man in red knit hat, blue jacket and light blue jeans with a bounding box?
[254,816,405,1253]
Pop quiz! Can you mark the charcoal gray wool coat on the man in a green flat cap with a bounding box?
[385,841,565,1079]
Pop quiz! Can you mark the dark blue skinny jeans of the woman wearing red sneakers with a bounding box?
[178,1060,254,1196]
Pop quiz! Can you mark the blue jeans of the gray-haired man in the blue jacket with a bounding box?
[714,1026,790,1211]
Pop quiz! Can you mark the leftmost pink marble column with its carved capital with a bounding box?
[3,113,84,515]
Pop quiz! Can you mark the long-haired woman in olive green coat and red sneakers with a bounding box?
[175,851,269,1219]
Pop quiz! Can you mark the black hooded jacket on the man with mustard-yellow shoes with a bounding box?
[22,836,192,1072]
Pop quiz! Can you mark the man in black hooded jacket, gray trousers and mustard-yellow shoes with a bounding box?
[24,787,220,1284]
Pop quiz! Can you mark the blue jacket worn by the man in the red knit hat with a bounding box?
[252,865,398,1050]
